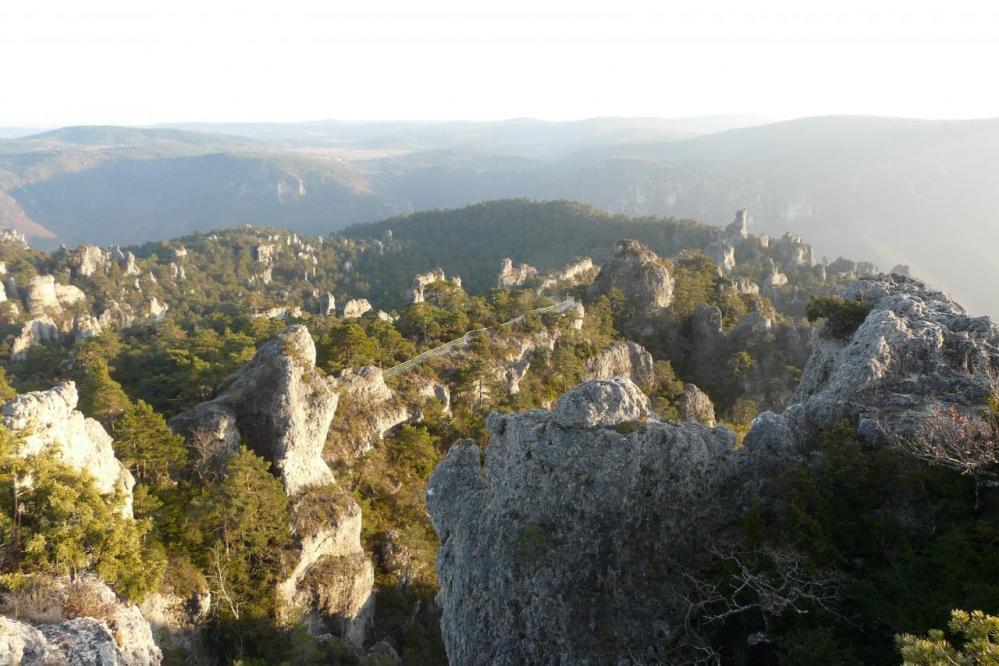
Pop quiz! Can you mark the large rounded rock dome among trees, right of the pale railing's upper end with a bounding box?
[587,240,673,315]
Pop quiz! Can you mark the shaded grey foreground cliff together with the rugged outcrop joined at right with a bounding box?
[427,275,999,664]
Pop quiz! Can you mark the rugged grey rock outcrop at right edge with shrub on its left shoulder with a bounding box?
[757,274,999,441]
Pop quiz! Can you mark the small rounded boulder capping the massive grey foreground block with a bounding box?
[554,377,655,428]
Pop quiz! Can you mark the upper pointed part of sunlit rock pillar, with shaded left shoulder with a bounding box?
[170,326,338,494]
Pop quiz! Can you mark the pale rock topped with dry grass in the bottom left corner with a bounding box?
[0,575,163,666]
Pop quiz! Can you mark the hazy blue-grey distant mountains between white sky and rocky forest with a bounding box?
[0,116,999,311]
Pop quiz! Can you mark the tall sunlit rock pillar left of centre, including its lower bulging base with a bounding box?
[170,326,376,645]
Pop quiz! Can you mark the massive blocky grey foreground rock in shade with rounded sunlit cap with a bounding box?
[427,380,751,665]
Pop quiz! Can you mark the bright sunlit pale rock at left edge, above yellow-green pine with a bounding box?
[0,381,135,516]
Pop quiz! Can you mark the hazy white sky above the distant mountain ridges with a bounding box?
[0,0,999,126]
